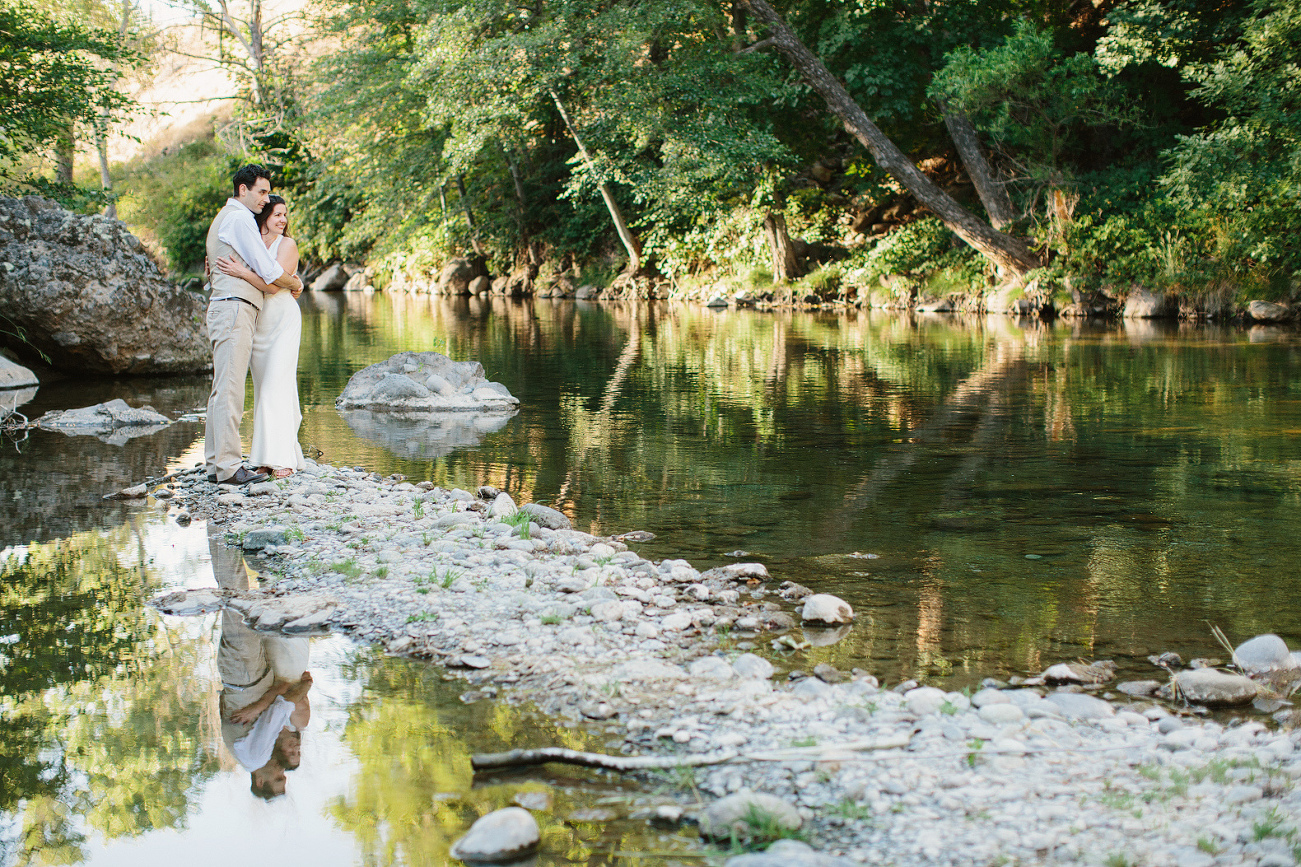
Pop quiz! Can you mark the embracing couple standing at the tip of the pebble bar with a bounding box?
[204,165,304,484]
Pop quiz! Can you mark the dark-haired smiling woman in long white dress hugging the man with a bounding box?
[217,195,306,479]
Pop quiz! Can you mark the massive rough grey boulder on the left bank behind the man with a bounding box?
[0,195,212,375]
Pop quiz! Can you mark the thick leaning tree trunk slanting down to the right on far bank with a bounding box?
[739,0,1042,275]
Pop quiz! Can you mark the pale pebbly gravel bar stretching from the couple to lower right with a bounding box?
[152,462,1301,867]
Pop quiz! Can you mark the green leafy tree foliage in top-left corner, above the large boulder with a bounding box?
[0,0,135,185]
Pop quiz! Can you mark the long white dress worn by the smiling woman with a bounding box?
[248,238,306,470]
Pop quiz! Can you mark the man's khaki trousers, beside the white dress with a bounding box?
[203,298,258,480]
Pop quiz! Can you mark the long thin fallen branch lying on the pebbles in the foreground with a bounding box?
[470,732,913,772]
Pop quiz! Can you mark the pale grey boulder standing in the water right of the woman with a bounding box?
[334,353,519,415]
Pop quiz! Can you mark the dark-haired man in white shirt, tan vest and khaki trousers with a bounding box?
[204,165,302,484]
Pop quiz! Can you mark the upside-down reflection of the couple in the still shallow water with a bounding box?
[208,527,312,799]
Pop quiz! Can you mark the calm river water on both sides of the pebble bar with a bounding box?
[0,294,1301,867]
